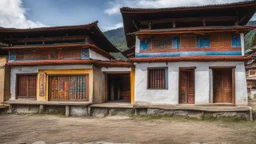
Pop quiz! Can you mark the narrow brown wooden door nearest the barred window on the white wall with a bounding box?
[179,70,195,104]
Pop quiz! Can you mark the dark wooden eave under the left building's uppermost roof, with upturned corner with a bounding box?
[0,21,120,52]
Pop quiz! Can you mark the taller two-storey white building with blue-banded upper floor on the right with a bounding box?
[121,1,256,105]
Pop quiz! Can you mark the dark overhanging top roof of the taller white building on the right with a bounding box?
[121,1,256,47]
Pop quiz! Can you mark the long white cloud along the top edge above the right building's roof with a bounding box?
[105,0,247,15]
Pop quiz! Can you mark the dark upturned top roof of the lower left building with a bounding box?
[0,21,120,52]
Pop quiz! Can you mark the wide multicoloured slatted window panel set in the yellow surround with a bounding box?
[49,75,89,100]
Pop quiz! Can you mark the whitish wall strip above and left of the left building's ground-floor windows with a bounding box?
[10,65,92,100]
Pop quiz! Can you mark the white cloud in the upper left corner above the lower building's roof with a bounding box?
[0,0,47,28]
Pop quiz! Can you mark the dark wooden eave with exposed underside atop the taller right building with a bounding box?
[121,1,256,47]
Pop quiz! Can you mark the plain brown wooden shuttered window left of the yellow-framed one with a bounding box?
[17,75,37,98]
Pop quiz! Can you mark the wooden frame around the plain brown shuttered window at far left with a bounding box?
[15,73,38,100]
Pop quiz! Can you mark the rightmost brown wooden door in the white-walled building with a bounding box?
[213,69,232,103]
